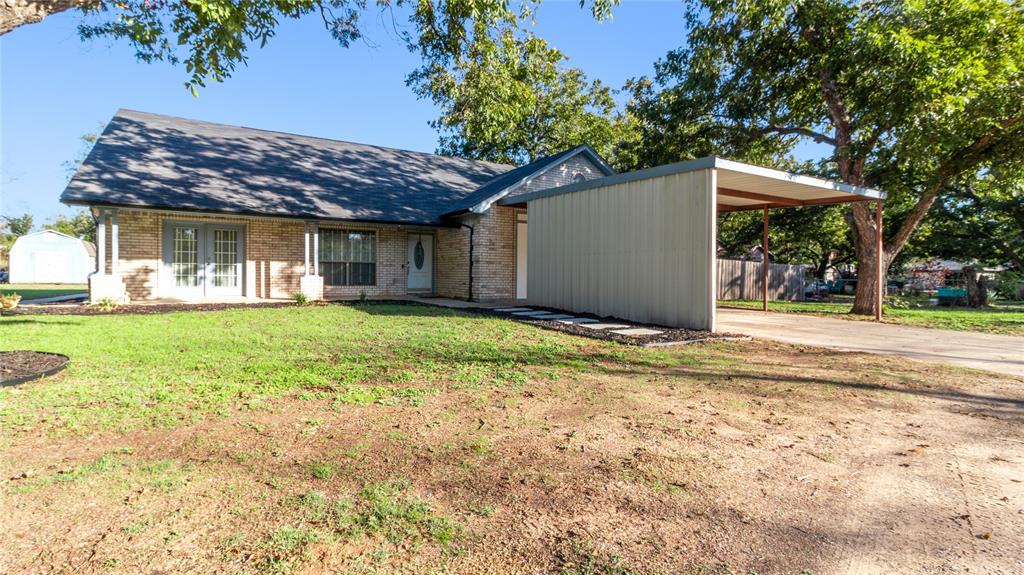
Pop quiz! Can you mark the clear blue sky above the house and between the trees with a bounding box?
[0,0,683,226]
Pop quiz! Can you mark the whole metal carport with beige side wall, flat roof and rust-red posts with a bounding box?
[500,157,885,330]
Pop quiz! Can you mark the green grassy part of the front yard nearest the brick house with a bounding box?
[0,304,688,430]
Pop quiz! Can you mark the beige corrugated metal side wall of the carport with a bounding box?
[527,170,716,329]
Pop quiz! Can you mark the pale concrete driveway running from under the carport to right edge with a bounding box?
[718,308,1024,378]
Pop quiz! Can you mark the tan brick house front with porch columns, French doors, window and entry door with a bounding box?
[89,207,512,304]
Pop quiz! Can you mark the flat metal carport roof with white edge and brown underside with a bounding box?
[500,156,886,212]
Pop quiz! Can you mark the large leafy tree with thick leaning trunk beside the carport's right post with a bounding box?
[634,0,1024,313]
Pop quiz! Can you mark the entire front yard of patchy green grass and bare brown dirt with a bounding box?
[0,304,1024,575]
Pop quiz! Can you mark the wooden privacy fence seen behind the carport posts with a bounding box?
[718,255,804,300]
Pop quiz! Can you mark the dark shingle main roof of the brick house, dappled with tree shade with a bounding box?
[60,110,516,224]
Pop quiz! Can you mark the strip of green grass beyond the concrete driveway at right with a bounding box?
[718,298,1024,336]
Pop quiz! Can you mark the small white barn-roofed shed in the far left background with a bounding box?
[9,229,96,283]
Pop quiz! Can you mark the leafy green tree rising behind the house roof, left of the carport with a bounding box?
[408,12,628,164]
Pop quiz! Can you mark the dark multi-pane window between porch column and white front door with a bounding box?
[319,229,377,285]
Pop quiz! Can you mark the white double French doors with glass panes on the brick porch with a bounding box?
[163,222,245,299]
